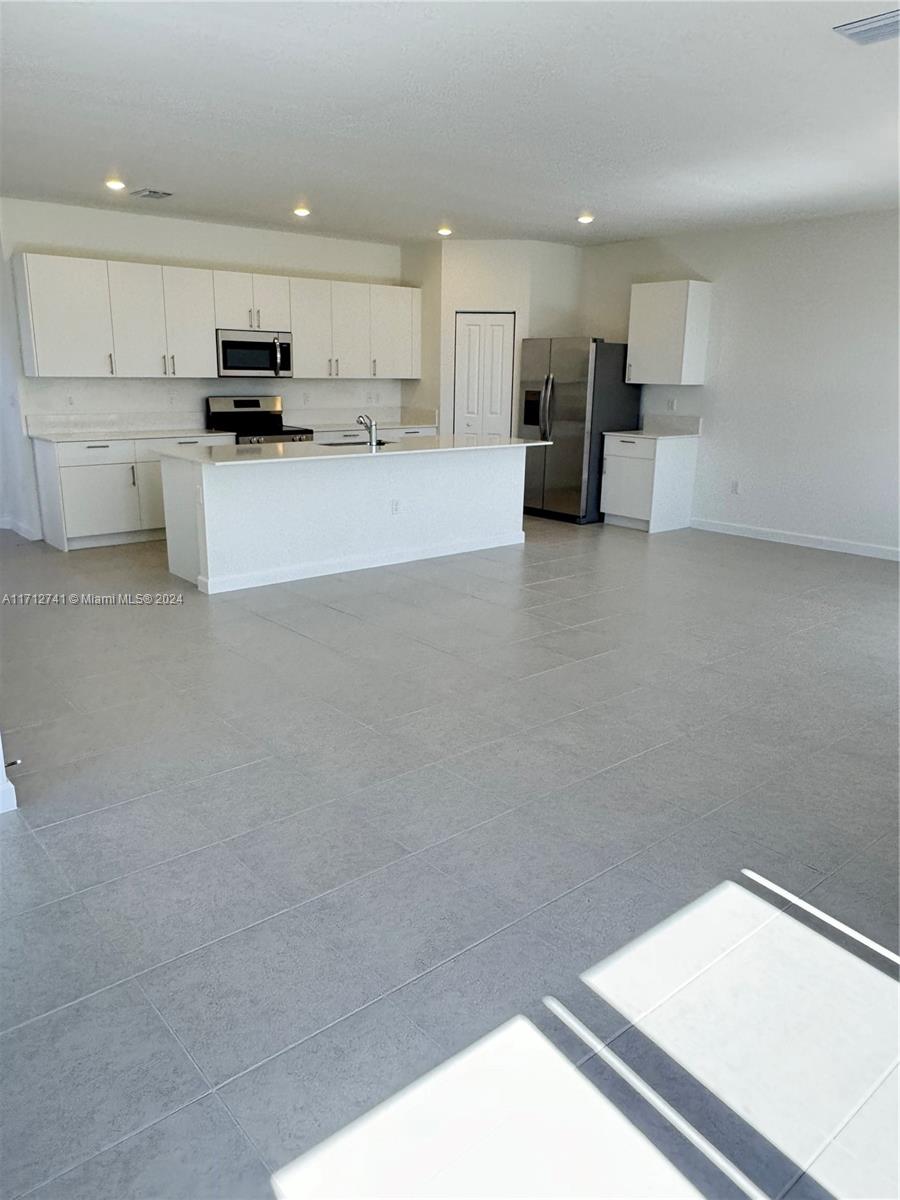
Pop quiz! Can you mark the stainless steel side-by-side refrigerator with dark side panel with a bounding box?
[518,337,641,524]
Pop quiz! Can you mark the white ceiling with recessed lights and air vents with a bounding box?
[0,0,898,242]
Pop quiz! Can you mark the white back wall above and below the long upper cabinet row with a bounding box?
[0,198,401,536]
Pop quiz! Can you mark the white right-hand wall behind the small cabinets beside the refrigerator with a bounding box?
[582,212,898,554]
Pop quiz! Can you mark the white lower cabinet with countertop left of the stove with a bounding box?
[34,433,234,550]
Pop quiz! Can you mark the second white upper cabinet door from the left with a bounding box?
[107,263,169,379]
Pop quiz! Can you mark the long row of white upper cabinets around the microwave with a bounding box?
[13,253,421,379]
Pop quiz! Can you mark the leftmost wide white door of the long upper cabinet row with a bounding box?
[20,254,113,377]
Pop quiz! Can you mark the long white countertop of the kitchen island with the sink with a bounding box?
[160,434,551,467]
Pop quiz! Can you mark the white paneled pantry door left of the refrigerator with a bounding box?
[454,312,515,438]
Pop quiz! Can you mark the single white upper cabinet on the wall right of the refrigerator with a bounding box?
[625,280,713,384]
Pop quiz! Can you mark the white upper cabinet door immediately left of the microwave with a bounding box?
[162,266,217,379]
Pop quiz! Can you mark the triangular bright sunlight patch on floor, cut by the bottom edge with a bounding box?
[272,1016,701,1200]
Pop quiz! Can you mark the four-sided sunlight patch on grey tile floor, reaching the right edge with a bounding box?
[582,883,899,1196]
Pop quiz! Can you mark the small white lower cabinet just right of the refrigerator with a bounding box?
[600,433,697,533]
